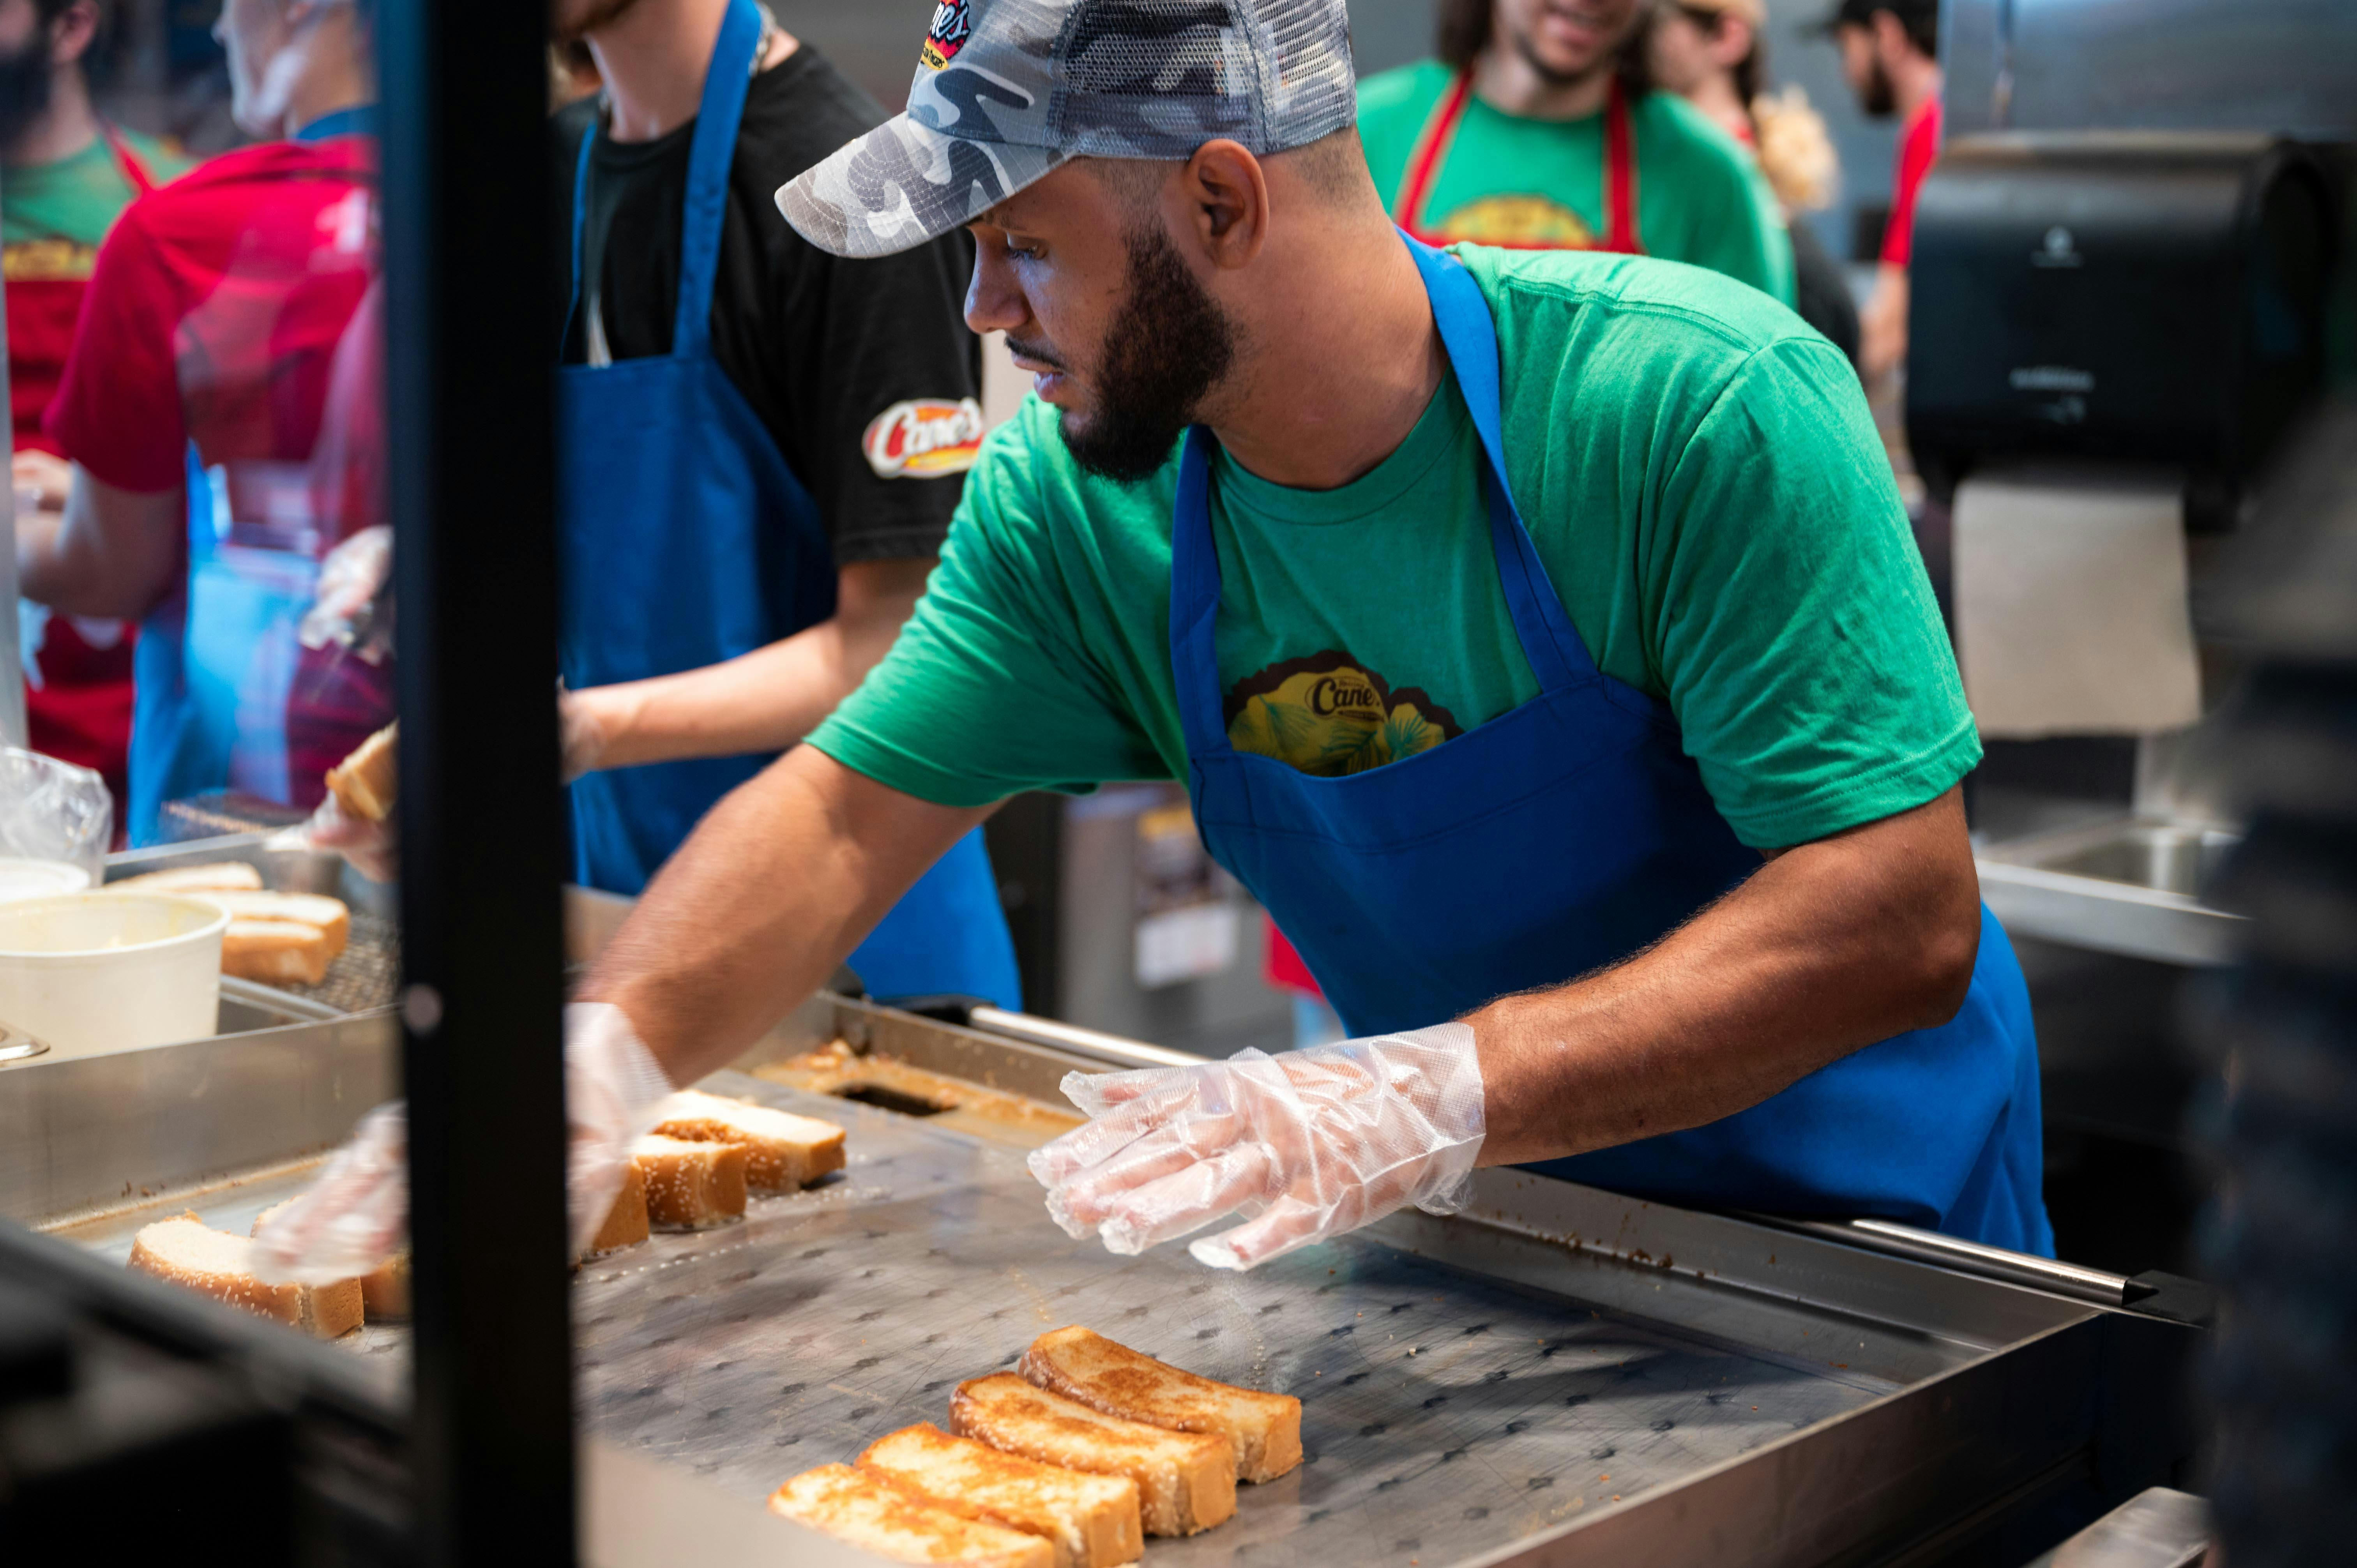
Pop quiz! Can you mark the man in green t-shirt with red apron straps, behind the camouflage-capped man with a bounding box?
[1358,0,1794,304]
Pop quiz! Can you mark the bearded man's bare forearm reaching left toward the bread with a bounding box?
[580,745,990,1085]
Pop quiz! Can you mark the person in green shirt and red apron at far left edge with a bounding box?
[0,0,189,823]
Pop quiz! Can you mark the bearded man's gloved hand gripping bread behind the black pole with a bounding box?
[254,1002,672,1285]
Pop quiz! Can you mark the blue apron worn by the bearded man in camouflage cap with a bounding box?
[1171,240,2053,1254]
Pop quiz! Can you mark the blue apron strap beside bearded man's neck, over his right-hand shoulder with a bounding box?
[1400,231,1595,691]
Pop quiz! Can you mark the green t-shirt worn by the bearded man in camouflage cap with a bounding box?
[811,247,1980,849]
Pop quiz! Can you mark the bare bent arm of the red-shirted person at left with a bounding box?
[16,464,189,620]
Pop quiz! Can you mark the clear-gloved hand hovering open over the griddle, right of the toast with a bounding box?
[1030,1023,1482,1269]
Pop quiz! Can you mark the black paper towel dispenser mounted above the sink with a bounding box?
[1907,132,2336,526]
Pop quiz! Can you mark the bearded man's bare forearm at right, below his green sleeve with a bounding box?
[1466,790,1980,1165]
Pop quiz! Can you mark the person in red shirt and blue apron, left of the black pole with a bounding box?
[16,0,391,844]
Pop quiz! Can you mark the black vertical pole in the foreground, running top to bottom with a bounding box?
[373,0,575,1566]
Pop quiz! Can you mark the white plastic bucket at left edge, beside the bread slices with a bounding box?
[0,893,229,1061]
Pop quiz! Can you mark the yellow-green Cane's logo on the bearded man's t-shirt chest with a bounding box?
[1226,651,1464,778]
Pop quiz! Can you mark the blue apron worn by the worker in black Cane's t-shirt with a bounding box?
[556,0,1021,1007]
